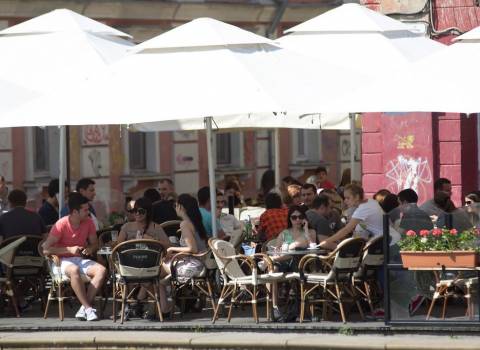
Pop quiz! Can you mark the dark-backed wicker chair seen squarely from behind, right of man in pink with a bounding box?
[111,239,165,324]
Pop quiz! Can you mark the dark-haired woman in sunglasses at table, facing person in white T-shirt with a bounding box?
[271,206,316,319]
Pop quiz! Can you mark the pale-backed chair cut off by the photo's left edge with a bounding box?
[0,237,27,317]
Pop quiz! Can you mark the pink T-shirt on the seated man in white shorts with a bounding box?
[50,216,97,257]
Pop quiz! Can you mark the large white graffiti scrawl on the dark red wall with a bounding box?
[385,154,432,196]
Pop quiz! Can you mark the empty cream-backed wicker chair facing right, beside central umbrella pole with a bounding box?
[208,238,286,323]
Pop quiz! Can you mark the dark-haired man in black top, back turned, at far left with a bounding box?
[0,190,47,242]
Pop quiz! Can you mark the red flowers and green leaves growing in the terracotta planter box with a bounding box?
[398,228,480,252]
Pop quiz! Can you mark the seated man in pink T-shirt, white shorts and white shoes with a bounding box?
[42,192,106,321]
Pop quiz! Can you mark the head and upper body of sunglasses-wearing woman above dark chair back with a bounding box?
[118,197,170,248]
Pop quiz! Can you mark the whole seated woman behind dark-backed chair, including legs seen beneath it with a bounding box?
[118,197,170,318]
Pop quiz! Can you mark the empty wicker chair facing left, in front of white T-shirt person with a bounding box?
[298,238,365,323]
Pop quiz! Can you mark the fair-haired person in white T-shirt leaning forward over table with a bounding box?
[320,184,383,250]
